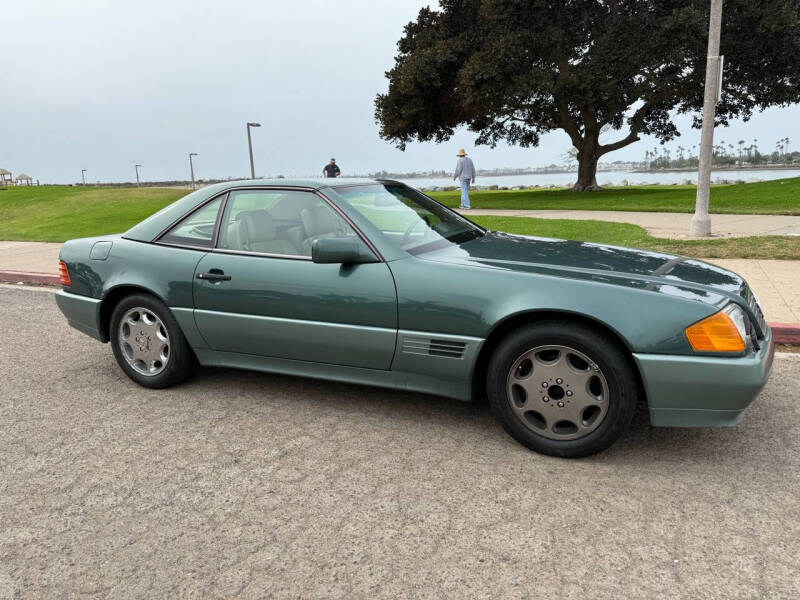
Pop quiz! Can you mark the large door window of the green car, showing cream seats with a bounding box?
[219,190,356,256]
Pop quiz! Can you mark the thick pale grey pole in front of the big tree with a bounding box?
[689,0,722,237]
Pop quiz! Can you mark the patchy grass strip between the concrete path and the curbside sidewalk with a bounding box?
[471,215,800,260]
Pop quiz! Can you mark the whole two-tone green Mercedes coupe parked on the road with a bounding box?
[56,179,773,457]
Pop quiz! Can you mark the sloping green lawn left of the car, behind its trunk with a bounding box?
[0,186,183,242]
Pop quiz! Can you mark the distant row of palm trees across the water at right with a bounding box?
[644,137,800,169]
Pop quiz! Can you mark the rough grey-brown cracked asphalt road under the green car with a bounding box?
[0,287,800,598]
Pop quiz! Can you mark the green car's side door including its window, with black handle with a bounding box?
[194,190,397,369]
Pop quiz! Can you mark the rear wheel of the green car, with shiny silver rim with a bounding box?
[109,294,196,389]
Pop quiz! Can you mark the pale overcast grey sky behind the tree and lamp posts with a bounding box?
[0,0,800,183]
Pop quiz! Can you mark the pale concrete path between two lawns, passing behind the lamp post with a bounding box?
[461,208,800,239]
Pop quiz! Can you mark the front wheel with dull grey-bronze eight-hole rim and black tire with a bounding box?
[486,320,637,458]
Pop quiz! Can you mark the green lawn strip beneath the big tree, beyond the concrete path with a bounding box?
[429,177,800,215]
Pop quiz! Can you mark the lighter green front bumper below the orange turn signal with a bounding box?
[633,329,775,427]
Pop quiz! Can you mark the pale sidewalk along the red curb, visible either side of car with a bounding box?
[0,239,800,323]
